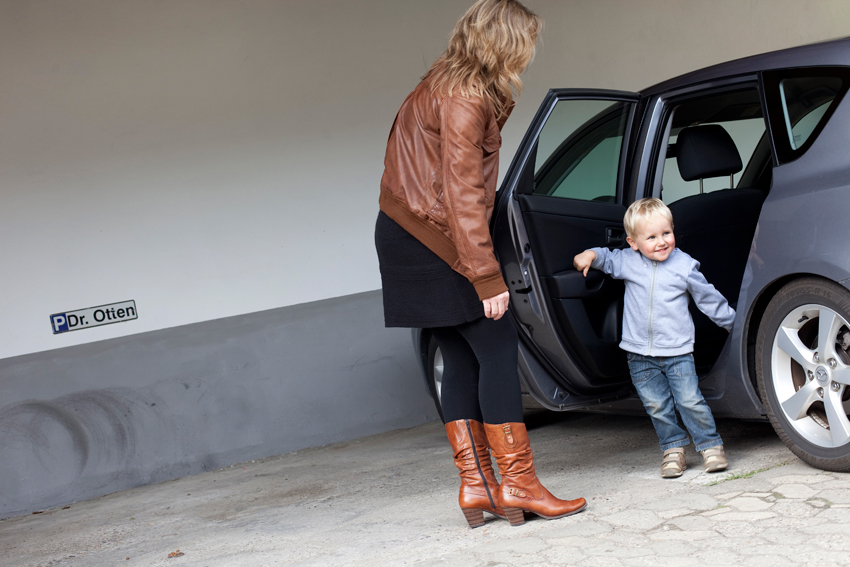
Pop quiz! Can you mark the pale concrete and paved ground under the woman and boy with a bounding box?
[0,412,850,567]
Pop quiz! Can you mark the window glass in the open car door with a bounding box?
[533,100,631,203]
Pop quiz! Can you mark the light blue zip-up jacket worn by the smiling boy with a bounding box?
[591,248,735,356]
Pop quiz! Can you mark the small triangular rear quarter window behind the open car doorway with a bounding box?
[764,67,850,163]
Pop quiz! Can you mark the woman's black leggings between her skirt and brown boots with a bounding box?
[431,314,522,424]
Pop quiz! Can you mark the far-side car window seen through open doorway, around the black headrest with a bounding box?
[654,88,766,204]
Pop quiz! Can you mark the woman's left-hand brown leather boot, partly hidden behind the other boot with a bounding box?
[446,419,505,528]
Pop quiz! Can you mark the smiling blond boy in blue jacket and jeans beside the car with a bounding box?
[573,199,735,478]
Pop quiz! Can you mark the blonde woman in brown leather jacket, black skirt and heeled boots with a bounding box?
[375,0,586,528]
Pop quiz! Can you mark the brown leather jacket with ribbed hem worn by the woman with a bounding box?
[380,79,508,300]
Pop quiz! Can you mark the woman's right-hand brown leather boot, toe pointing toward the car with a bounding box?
[484,423,587,526]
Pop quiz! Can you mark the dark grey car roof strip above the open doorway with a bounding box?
[640,37,850,96]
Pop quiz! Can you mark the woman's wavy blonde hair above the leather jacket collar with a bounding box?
[423,0,543,118]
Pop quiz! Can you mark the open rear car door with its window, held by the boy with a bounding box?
[493,89,639,410]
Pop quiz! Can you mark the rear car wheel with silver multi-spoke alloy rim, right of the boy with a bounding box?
[756,278,850,471]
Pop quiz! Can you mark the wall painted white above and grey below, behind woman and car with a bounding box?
[0,0,850,517]
